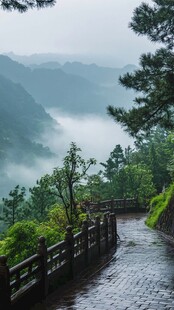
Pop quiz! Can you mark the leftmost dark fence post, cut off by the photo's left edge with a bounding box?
[0,256,11,310]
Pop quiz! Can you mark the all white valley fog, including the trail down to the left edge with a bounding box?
[0,109,133,196]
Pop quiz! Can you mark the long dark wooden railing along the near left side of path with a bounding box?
[0,213,117,310]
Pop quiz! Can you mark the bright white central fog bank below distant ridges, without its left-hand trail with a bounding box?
[44,109,133,168]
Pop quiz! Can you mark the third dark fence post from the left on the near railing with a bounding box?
[65,226,74,279]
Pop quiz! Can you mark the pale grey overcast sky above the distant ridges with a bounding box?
[0,0,159,66]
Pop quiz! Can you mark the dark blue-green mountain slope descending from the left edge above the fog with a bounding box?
[0,76,54,167]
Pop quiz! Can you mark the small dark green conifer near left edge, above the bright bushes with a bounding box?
[2,185,26,226]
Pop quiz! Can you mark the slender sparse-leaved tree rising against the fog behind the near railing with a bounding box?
[50,142,96,225]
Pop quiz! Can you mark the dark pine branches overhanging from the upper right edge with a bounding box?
[108,0,174,136]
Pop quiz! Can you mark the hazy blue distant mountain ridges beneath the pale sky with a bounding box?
[0,55,134,114]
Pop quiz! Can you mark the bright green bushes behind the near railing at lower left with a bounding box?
[0,221,63,267]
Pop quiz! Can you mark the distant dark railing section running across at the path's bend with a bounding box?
[85,198,146,214]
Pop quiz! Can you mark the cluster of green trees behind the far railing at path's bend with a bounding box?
[102,145,156,206]
